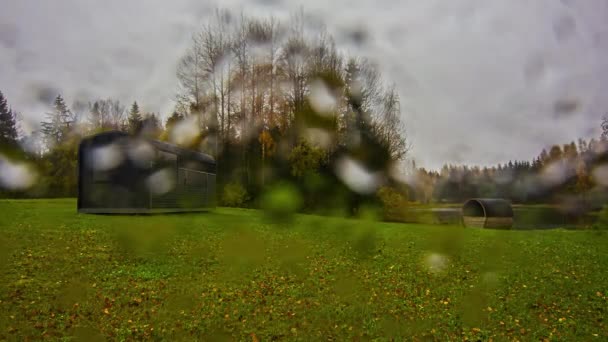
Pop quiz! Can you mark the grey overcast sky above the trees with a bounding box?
[0,0,608,168]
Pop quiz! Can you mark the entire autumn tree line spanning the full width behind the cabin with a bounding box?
[0,11,608,213]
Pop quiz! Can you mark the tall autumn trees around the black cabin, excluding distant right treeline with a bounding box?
[3,11,409,215]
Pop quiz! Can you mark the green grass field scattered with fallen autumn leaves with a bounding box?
[0,200,608,341]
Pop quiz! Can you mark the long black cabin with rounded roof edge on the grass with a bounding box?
[78,131,216,214]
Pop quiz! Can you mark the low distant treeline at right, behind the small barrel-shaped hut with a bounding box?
[410,135,608,208]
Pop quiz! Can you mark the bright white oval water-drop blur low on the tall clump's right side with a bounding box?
[336,157,380,194]
